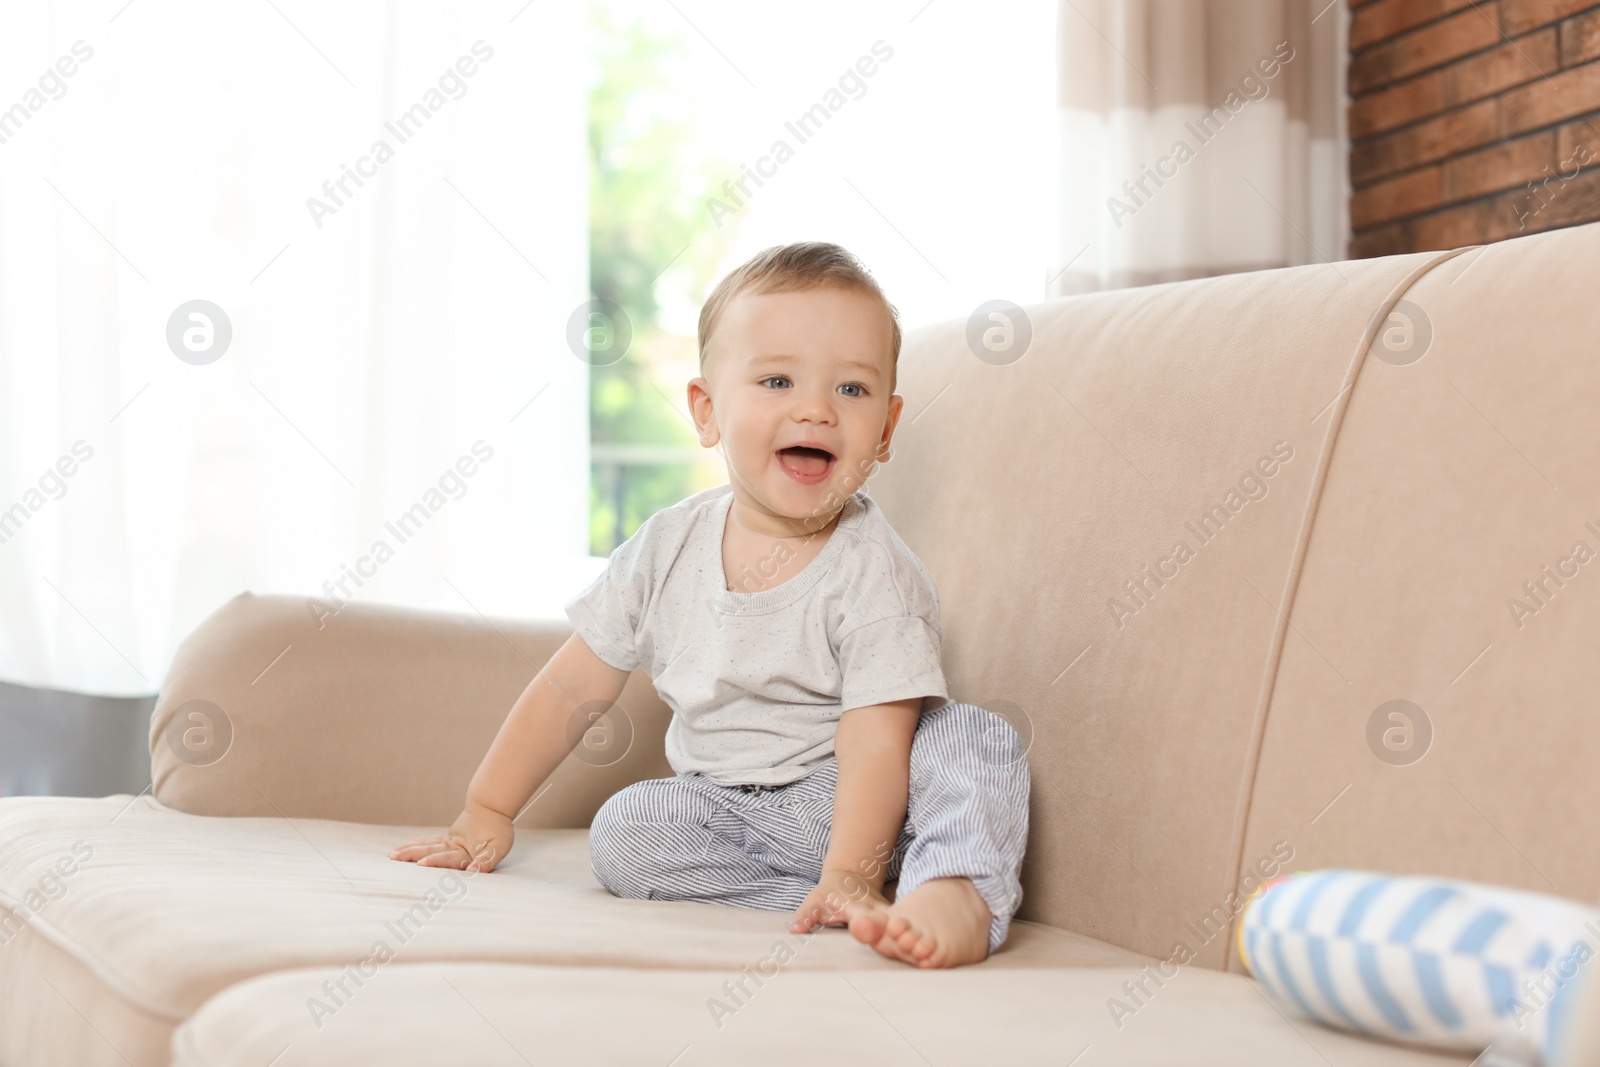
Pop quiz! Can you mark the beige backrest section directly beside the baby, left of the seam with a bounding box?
[869,241,1465,966]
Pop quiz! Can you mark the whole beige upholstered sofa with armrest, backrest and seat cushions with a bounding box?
[0,224,1600,1067]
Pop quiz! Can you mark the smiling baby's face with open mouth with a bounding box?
[690,286,904,526]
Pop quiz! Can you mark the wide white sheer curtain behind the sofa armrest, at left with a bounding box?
[0,0,589,694]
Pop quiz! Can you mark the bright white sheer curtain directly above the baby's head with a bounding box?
[629,0,1070,334]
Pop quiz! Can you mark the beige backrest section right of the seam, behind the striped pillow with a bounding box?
[1228,226,1600,966]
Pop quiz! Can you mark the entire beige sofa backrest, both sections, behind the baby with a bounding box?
[867,226,1600,968]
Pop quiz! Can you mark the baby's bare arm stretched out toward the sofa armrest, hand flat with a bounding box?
[389,633,630,870]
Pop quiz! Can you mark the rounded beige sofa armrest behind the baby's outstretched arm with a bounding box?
[150,592,672,827]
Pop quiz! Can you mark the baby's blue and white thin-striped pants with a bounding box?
[589,704,1029,952]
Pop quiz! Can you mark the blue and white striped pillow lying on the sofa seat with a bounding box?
[1238,870,1600,1067]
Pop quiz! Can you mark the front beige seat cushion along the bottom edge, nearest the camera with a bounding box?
[173,957,1470,1067]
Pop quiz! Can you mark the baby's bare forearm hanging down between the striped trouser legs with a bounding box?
[822,696,922,897]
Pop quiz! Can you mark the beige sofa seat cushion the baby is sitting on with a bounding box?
[0,796,1146,1067]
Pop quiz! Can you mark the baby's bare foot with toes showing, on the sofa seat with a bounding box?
[850,878,994,968]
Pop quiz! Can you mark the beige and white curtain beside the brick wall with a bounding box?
[1050,0,1349,294]
